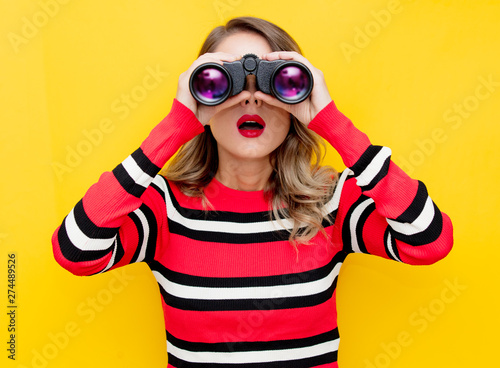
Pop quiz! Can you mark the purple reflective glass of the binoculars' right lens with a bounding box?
[274,66,311,101]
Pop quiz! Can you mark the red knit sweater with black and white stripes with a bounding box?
[52,99,453,368]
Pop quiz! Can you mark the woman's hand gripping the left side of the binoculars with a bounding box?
[175,52,251,125]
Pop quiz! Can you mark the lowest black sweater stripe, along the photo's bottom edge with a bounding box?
[168,351,337,368]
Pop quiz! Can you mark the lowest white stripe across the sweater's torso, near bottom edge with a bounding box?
[167,339,340,364]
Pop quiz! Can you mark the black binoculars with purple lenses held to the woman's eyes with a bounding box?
[189,54,313,106]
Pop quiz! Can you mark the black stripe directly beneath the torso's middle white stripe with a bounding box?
[158,277,338,312]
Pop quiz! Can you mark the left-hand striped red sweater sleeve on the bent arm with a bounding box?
[52,99,203,275]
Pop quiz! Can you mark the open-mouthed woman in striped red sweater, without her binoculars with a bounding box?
[53,17,453,367]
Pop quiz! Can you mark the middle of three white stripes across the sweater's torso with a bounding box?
[153,262,342,300]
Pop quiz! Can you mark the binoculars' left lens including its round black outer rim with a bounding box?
[189,63,232,106]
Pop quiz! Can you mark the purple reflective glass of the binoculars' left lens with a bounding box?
[193,68,229,103]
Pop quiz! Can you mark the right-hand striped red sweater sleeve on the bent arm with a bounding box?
[309,101,453,265]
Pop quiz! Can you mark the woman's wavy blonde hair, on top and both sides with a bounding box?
[161,17,338,246]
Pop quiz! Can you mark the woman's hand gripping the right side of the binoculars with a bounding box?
[255,51,332,126]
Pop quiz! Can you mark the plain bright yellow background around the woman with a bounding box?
[0,0,500,368]
